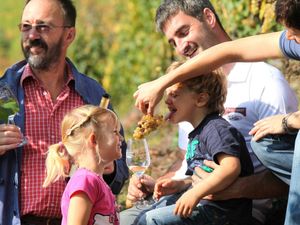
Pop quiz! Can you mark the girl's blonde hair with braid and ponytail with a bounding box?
[43,105,120,187]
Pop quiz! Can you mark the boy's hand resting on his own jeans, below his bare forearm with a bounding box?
[174,189,199,217]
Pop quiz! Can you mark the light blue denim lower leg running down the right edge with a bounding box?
[284,132,300,225]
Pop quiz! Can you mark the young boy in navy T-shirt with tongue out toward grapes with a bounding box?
[138,63,253,225]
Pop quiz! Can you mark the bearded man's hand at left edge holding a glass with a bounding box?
[0,124,23,155]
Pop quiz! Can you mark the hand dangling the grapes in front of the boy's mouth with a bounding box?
[133,79,164,115]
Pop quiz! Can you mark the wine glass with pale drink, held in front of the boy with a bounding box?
[126,138,150,207]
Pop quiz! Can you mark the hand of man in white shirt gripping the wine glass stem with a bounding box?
[127,174,155,202]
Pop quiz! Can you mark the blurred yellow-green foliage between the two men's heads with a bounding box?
[72,0,172,111]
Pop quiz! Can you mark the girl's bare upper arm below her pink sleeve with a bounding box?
[67,192,93,225]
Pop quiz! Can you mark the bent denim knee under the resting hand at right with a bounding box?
[251,135,296,185]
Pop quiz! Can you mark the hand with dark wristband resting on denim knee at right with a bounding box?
[249,115,285,141]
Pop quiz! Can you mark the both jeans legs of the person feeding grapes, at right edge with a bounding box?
[251,132,300,225]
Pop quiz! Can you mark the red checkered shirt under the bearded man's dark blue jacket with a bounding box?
[20,65,84,217]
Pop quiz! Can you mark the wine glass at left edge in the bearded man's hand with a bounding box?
[0,82,27,147]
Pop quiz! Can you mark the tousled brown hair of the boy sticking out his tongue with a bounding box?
[167,62,227,114]
